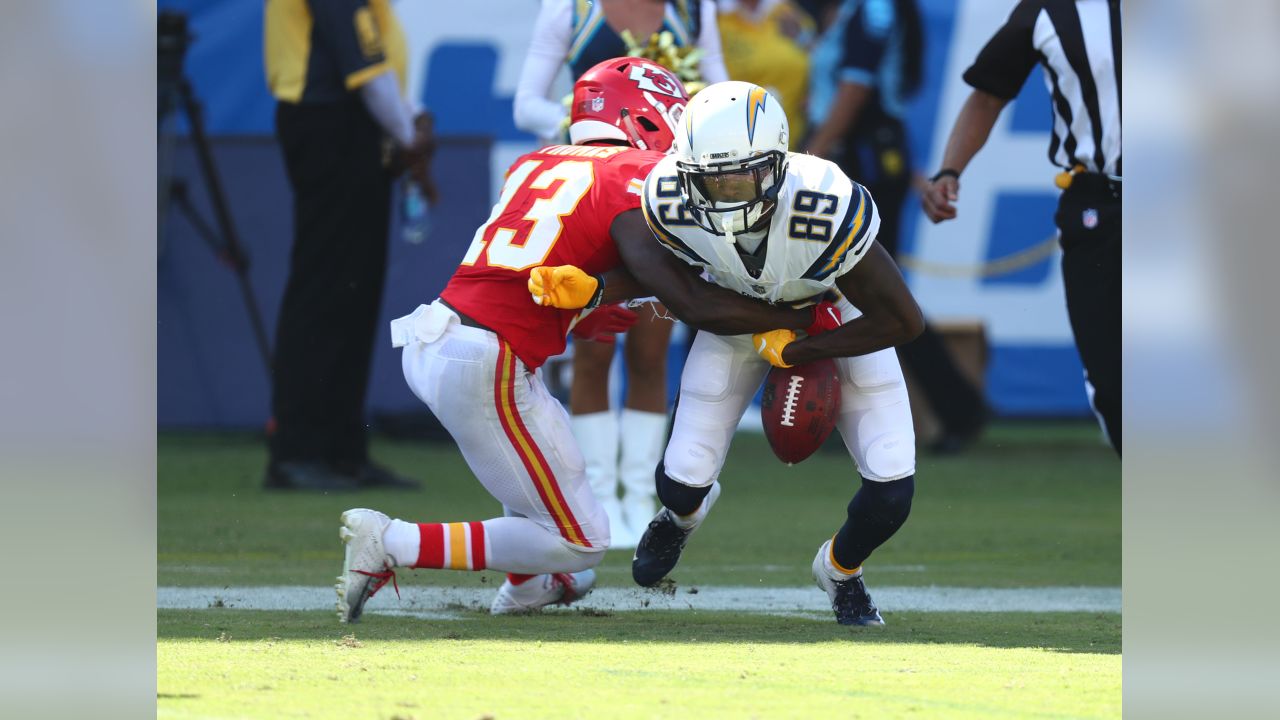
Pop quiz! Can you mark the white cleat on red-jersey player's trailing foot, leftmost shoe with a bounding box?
[334,507,399,623]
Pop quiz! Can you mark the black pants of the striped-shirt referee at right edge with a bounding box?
[1053,173,1121,454]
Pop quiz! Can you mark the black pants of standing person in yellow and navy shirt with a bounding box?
[270,96,392,465]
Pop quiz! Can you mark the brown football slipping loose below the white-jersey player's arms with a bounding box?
[760,360,840,465]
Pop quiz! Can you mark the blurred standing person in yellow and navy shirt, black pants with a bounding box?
[265,0,435,491]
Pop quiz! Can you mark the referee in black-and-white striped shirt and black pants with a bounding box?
[923,0,1121,454]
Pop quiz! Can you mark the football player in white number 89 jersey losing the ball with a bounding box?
[632,82,923,625]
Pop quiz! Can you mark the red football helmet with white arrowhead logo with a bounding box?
[568,58,689,152]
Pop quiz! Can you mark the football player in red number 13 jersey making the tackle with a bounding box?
[337,58,813,621]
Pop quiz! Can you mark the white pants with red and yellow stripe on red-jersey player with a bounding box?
[392,301,609,573]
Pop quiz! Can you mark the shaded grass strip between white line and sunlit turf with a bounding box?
[156,609,1120,655]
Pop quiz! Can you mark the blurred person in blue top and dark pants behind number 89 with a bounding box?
[805,0,988,454]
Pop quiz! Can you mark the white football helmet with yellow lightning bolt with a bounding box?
[673,81,787,242]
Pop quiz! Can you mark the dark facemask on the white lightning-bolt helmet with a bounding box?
[676,150,786,242]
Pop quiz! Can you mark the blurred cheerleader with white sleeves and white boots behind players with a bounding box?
[515,0,727,548]
